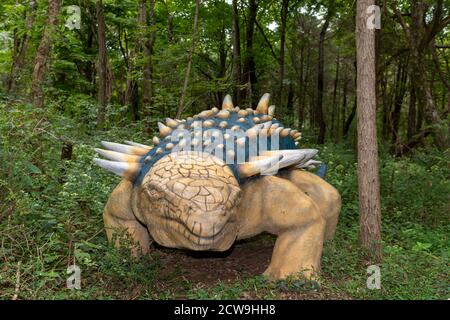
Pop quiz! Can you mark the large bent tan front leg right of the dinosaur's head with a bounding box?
[239,176,326,279]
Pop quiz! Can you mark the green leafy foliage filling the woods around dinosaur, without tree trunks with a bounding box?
[0,0,450,299]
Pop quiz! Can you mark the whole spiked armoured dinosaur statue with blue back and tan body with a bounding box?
[94,93,341,279]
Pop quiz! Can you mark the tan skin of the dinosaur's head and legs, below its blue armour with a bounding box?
[104,155,341,279]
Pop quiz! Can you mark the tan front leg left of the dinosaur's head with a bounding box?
[103,180,150,256]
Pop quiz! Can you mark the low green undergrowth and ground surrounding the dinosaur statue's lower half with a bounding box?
[0,102,450,299]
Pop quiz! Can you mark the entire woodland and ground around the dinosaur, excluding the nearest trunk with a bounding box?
[0,0,450,299]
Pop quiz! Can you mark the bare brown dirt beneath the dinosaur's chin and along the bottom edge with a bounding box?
[148,234,349,299]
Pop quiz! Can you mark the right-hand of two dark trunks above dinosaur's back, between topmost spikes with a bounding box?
[243,0,258,107]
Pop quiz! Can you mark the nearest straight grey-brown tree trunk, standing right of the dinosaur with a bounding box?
[356,0,381,262]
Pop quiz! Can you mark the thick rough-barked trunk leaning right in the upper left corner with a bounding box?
[31,0,61,108]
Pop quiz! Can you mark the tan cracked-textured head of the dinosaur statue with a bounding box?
[132,151,240,251]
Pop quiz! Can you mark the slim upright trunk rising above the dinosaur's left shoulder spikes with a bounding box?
[95,0,108,129]
